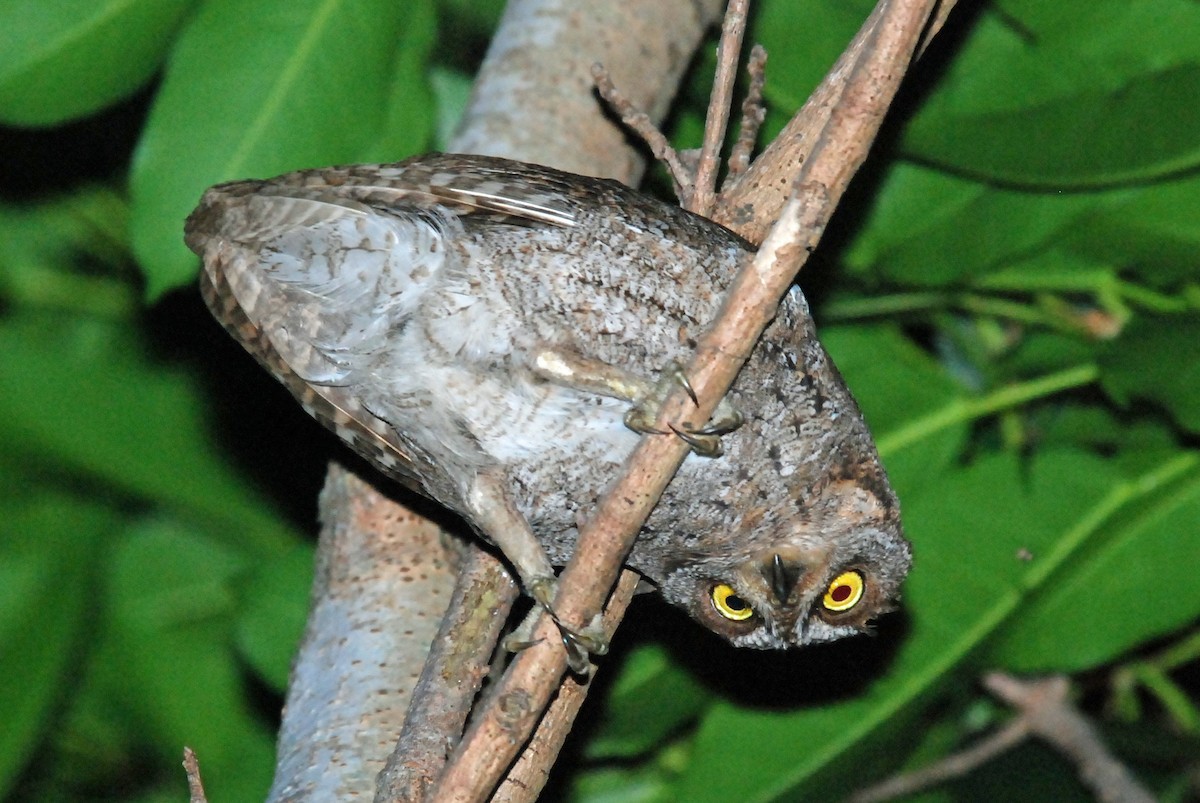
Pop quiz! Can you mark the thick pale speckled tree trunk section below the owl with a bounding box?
[268,467,455,801]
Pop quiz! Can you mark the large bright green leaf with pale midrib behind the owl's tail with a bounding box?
[131,0,416,298]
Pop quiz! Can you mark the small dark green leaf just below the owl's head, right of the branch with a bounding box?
[587,645,708,759]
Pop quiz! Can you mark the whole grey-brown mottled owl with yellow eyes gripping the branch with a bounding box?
[186,155,911,662]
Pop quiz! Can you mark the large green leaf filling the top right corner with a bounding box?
[902,0,1200,188]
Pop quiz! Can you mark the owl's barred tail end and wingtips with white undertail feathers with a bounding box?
[186,170,477,496]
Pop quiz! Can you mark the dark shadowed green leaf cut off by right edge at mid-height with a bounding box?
[1100,314,1200,432]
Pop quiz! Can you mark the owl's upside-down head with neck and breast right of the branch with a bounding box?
[648,284,912,648]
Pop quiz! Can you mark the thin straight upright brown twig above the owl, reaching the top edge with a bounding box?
[682,0,750,217]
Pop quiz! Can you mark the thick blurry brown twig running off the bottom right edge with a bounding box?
[983,672,1154,803]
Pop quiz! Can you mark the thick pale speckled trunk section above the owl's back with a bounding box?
[452,0,725,178]
